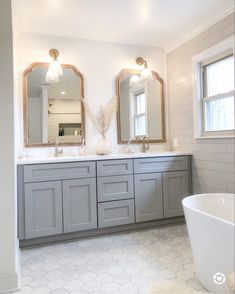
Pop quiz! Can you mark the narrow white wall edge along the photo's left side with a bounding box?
[0,0,18,293]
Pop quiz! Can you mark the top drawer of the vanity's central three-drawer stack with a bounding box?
[97,159,133,177]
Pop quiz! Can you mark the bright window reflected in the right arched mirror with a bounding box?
[134,92,146,136]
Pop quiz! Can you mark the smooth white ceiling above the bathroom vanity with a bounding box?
[13,0,233,50]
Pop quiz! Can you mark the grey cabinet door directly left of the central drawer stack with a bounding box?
[63,178,97,233]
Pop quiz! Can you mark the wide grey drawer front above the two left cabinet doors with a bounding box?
[24,162,96,182]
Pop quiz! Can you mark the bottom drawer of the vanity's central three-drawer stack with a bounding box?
[98,199,135,228]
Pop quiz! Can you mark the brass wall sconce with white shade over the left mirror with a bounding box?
[46,49,63,83]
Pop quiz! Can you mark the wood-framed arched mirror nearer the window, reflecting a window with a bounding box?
[116,69,166,144]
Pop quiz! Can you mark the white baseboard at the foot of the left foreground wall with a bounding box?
[0,272,19,294]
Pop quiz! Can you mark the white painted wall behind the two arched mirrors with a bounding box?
[17,34,167,154]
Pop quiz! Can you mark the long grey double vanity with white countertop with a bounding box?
[18,152,191,247]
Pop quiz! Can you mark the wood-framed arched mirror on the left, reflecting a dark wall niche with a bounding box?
[23,62,85,147]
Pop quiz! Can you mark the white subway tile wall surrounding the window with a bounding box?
[167,13,235,194]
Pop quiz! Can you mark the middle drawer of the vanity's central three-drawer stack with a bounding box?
[97,175,134,202]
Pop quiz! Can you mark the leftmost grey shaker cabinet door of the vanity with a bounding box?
[25,181,62,239]
